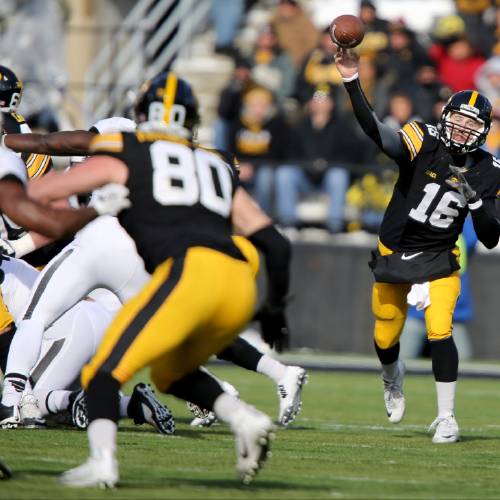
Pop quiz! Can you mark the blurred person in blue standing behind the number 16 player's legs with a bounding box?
[400,216,477,361]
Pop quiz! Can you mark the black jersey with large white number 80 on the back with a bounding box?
[90,132,243,272]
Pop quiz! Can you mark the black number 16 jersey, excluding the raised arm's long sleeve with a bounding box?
[380,122,500,250]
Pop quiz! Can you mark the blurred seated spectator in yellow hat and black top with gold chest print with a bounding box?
[229,87,288,214]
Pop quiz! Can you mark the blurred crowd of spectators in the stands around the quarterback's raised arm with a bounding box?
[215,0,500,233]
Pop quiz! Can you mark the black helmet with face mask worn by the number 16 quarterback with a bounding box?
[438,90,493,154]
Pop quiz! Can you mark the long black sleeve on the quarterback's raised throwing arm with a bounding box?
[344,78,408,161]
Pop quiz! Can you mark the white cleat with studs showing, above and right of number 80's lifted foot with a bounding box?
[278,366,308,427]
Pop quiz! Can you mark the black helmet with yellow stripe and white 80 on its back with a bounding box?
[135,71,200,133]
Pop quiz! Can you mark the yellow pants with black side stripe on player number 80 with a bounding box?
[82,247,256,391]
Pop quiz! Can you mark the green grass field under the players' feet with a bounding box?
[0,366,500,499]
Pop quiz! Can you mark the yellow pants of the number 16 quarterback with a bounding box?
[372,241,460,349]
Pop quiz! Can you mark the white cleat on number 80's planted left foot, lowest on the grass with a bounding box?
[59,450,120,488]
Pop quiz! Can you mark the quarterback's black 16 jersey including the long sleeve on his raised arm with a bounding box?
[345,78,500,251]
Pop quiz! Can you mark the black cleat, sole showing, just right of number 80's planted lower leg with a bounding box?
[127,383,175,434]
